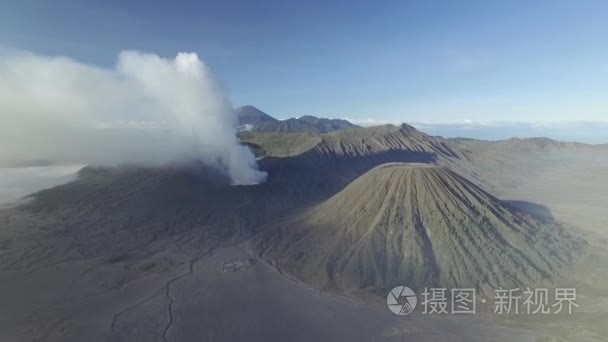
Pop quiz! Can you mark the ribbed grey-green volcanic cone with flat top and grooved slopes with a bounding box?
[258,163,580,292]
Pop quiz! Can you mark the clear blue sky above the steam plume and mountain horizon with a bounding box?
[0,0,608,142]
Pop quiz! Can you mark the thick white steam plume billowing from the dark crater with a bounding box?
[0,51,266,184]
